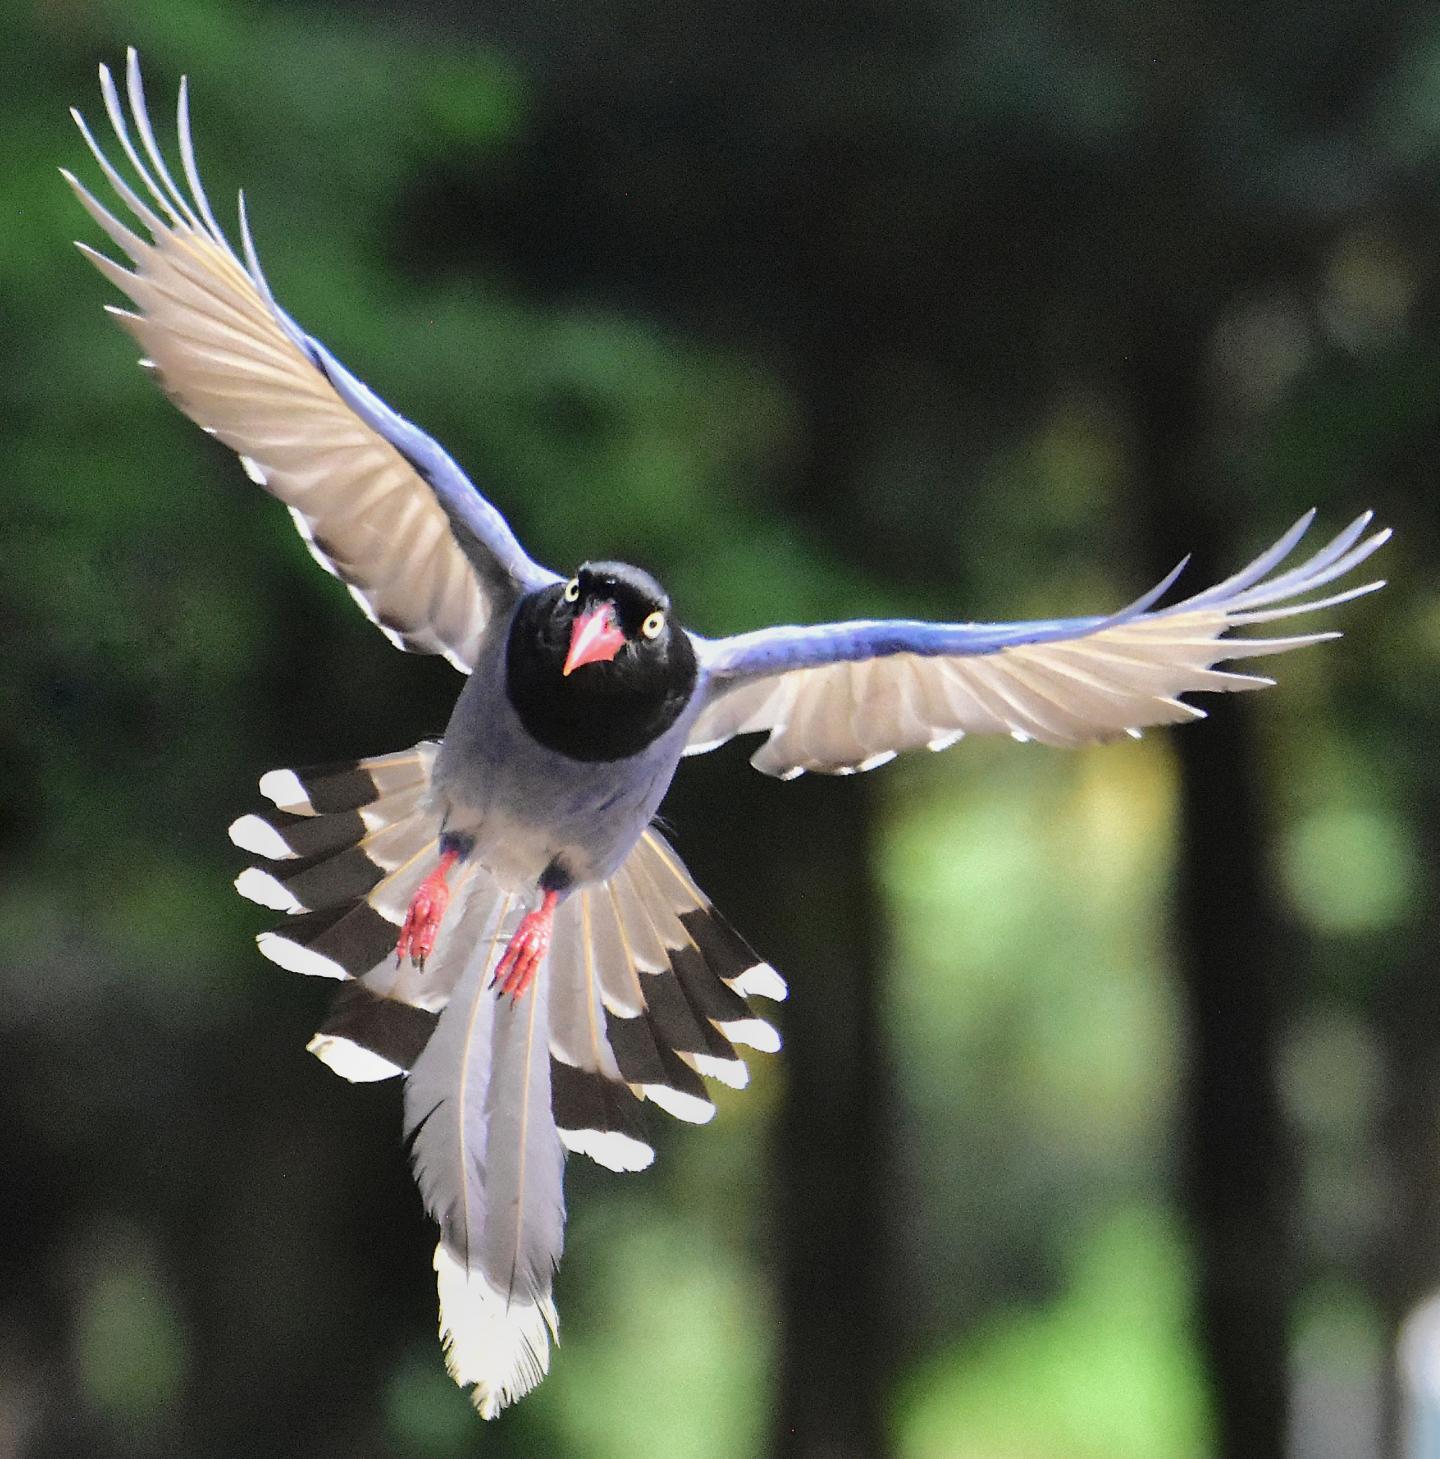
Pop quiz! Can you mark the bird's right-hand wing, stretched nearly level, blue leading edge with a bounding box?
[686,511,1390,779]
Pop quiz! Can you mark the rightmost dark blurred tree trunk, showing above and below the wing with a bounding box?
[1134,308,1297,1459]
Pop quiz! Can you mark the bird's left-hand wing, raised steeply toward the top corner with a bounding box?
[63,50,554,673]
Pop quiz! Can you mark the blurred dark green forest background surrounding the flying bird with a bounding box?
[0,0,1440,1459]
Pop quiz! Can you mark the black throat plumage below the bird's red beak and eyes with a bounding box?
[505,584,696,762]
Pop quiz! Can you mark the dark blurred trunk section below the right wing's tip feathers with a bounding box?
[1176,688,1297,1459]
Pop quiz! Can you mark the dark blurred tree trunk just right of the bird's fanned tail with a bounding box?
[773,355,894,1459]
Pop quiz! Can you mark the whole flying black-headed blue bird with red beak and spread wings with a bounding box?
[61,48,1389,1418]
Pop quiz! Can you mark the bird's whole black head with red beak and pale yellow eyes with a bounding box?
[505,562,696,760]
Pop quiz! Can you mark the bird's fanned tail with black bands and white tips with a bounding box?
[231,741,785,1417]
